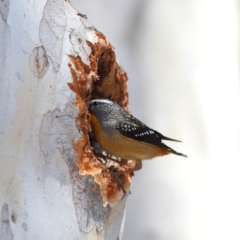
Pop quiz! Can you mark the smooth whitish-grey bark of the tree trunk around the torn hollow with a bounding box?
[0,0,126,240]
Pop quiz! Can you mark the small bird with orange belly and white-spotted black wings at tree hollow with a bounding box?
[88,99,187,171]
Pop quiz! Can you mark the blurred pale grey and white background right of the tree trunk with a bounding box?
[71,0,240,240]
